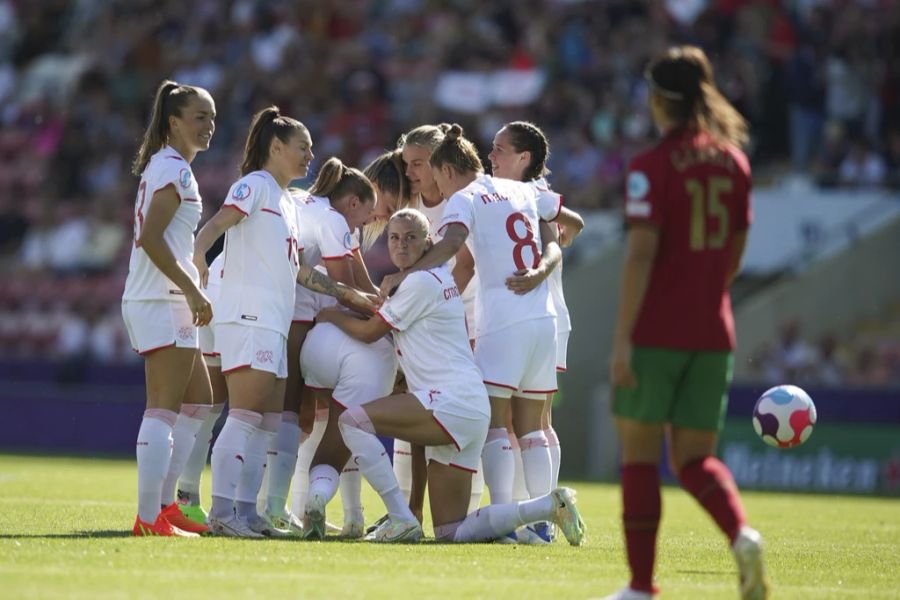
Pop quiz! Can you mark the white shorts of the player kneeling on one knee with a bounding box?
[412,390,491,473]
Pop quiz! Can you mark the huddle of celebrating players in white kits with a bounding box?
[123,81,584,545]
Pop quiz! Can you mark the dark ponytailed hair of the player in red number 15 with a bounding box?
[645,46,749,146]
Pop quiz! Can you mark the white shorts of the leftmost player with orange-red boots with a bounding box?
[122,300,199,356]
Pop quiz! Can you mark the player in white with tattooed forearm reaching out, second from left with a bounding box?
[194,106,367,537]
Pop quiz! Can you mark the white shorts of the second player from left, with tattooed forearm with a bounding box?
[215,323,287,379]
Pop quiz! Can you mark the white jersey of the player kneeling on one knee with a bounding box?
[378,267,490,415]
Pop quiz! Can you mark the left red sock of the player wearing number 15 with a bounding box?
[622,463,662,594]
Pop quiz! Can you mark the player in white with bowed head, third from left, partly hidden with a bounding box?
[265,158,378,533]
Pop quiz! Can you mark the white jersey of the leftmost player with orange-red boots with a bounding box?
[122,146,203,301]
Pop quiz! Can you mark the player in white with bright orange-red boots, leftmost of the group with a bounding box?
[122,81,216,536]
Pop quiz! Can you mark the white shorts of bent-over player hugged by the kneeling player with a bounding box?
[300,323,397,408]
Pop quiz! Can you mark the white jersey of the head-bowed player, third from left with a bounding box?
[291,191,359,313]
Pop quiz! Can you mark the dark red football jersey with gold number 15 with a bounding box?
[625,128,751,351]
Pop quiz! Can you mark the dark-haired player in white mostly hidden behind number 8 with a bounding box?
[488,121,584,541]
